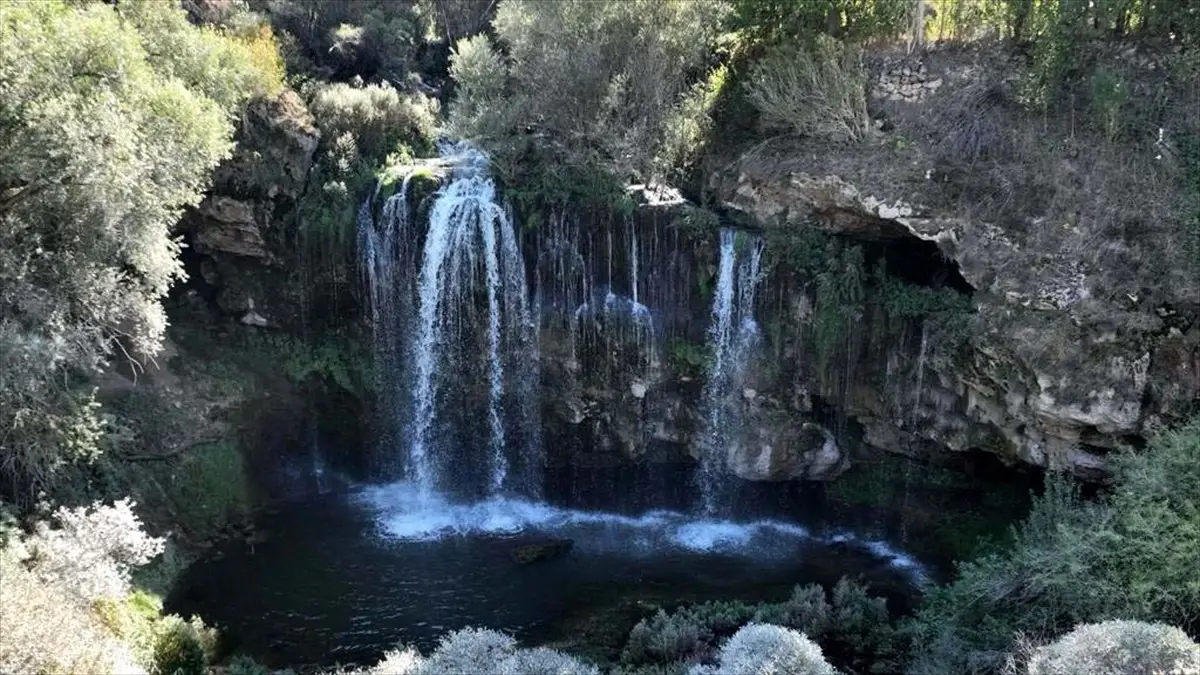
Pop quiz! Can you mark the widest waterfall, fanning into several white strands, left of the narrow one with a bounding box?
[359,145,542,496]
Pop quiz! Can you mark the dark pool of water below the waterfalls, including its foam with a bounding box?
[168,461,934,669]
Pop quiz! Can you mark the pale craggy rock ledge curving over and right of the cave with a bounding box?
[712,146,1200,478]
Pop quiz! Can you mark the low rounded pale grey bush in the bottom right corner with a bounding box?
[1028,621,1200,675]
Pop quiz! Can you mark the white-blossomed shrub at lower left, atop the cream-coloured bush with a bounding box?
[24,500,163,601]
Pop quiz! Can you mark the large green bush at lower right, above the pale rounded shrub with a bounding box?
[908,422,1200,674]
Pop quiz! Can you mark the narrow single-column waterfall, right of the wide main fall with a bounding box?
[698,229,763,514]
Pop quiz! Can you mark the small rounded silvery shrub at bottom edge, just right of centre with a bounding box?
[715,623,834,675]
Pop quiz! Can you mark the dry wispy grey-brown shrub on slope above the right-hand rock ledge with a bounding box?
[746,36,871,141]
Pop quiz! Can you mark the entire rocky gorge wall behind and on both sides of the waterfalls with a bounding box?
[177,64,1200,480]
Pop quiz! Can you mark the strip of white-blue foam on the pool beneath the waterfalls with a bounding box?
[355,483,930,585]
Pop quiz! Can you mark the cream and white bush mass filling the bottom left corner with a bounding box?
[0,502,199,675]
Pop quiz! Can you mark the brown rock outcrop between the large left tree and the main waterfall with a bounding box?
[182,90,319,328]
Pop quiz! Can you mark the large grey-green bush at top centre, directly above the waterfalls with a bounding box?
[451,0,725,183]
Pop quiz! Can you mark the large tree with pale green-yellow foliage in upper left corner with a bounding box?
[0,0,282,494]
